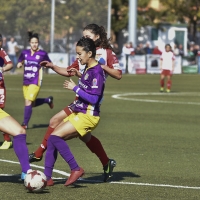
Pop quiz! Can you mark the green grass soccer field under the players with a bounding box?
[0,74,200,200]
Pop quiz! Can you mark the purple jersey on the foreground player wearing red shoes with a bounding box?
[74,64,106,116]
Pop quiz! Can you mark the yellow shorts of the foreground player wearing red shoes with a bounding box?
[63,113,100,136]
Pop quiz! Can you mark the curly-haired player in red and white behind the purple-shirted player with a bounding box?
[29,24,122,181]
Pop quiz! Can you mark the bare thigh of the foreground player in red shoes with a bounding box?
[51,121,78,139]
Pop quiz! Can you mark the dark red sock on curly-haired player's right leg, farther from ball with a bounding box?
[86,135,109,166]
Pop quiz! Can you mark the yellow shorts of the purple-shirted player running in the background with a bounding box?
[23,84,40,101]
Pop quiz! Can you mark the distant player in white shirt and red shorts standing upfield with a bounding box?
[160,44,175,93]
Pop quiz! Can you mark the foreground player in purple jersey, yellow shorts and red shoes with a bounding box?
[44,37,105,186]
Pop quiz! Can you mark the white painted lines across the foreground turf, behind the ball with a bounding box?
[0,159,200,190]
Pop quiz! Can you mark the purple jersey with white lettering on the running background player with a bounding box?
[18,49,51,86]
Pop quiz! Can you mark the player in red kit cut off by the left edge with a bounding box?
[0,34,13,149]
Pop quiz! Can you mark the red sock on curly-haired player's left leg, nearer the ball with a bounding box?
[34,126,54,158]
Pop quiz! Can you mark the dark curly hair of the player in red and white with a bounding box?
[83,24,113,50]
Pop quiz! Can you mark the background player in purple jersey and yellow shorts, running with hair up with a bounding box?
[17,32,53,129]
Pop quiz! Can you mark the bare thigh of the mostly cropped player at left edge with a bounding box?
[0,116,25,136]
